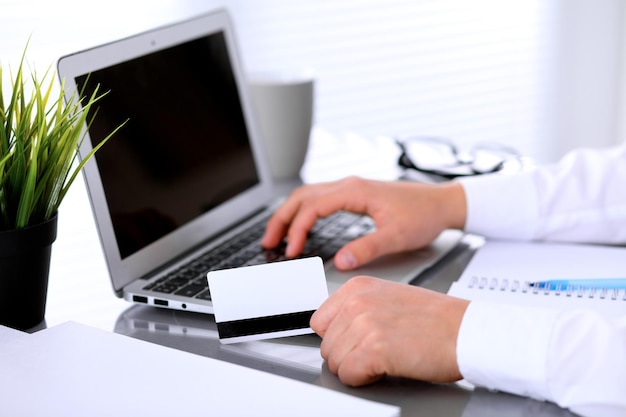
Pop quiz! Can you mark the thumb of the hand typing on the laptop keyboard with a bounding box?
[335,230,395,271]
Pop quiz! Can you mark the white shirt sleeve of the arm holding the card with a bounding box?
[457,301,626,417]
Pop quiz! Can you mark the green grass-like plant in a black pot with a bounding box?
[0,45,120,330]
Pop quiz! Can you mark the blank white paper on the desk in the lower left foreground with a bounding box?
[0,323,400,417]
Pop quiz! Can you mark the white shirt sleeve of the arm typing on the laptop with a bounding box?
[460,146,626,243]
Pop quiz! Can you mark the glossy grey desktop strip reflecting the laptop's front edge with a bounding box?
[115,306,574,417]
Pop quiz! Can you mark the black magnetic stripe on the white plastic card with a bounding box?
[217,310,315,339]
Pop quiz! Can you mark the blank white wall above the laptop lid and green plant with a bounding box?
[0,0,211,67]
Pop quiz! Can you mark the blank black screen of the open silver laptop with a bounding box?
[76,33,259,258]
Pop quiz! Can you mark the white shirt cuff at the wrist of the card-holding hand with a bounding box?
[457,301,558,400]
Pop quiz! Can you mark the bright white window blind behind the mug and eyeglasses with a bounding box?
[227,0,553,159]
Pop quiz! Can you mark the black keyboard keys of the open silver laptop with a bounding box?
[143,211,374,300]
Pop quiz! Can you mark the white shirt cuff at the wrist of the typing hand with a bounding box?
[458,172,539,240]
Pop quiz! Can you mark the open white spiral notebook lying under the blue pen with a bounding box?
[448,241,626,316]
